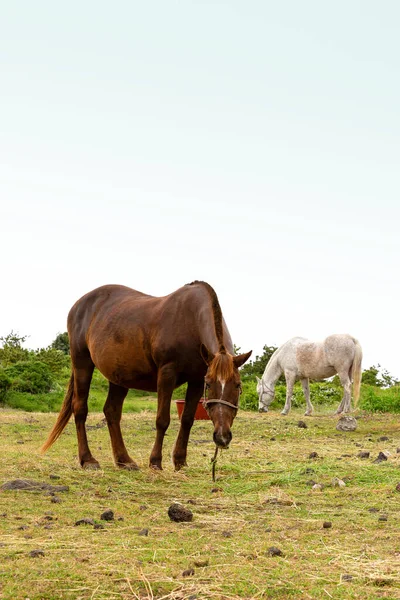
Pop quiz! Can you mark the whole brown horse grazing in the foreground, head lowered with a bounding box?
[42,281,251,469]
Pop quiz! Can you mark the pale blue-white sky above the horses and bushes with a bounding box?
[0,0,400,377]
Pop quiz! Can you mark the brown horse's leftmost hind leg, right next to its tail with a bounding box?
[72,357,100,469]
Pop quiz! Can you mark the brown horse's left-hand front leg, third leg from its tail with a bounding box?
[150,364,176,470]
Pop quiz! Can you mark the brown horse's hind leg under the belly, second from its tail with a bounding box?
[103,382,139,470]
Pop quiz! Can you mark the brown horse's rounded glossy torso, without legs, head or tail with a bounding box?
[68,285,232,391]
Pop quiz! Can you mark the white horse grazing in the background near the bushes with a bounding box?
[257,334,362,416]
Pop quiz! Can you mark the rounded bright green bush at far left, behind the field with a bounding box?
[4,360,54,394]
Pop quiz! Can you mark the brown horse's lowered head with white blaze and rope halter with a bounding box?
[201,344,251,448]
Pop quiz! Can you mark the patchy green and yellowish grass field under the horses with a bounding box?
[0,398,400,600]
